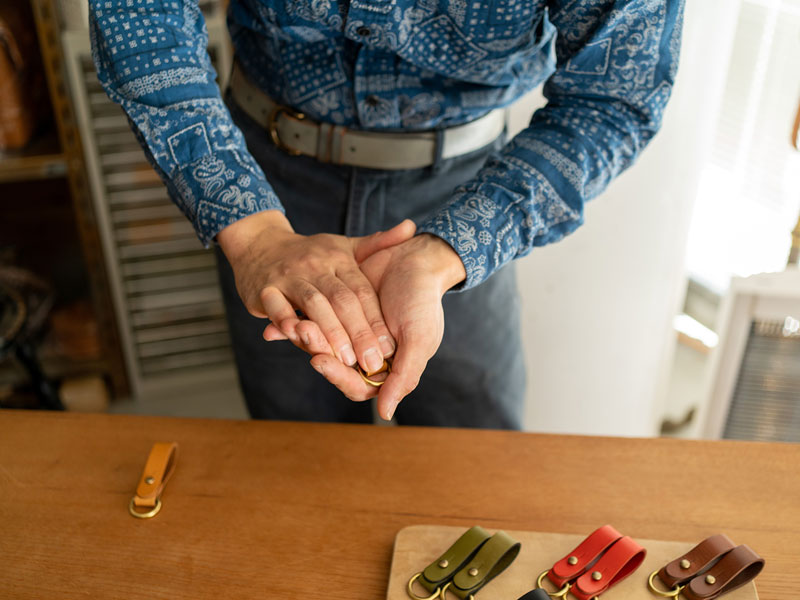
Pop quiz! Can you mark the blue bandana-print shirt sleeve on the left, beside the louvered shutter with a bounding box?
[89,0,283,245]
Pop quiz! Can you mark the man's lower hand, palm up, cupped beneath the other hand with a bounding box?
[311,234,466,421]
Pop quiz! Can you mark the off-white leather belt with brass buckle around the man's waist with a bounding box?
[230,65,506,170]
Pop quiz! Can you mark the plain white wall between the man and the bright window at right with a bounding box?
[517,0,738,436]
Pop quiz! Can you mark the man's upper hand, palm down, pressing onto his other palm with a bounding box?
[217,211,414,371]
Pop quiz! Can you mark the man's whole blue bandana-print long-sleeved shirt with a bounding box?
[90,0,683,288]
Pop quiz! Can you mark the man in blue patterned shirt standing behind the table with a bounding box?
[90,0,683,428]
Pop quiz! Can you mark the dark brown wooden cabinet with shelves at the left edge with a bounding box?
[0,0,130,396]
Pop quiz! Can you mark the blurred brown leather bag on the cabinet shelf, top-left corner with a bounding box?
[0,0,43,150]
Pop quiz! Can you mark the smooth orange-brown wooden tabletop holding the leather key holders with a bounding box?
[0,411,800,600]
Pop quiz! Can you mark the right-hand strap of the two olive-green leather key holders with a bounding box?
[441,531,521,600]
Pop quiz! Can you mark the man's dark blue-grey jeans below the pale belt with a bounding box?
[217,100,525,429]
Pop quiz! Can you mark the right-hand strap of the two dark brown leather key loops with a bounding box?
[683,545,764,600]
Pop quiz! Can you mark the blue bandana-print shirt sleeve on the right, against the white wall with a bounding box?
[418,0,683,289]
